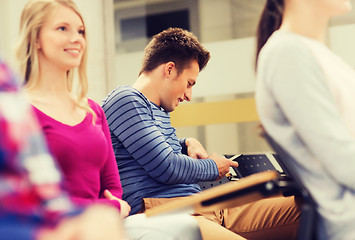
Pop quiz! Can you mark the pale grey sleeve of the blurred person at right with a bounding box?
[264,39,355,189]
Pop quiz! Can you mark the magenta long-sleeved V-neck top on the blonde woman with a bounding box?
[33,99,122,209]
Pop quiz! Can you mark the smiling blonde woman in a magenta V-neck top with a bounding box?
[17,0,130,217]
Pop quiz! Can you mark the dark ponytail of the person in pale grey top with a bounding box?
[255,0,284,68]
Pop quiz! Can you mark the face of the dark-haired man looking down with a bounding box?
[160,60,200,112]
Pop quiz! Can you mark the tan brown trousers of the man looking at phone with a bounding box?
[142,197,300,240]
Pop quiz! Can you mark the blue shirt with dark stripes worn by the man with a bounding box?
[102,86,218,214]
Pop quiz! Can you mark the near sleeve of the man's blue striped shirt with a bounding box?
[103,91,218,184]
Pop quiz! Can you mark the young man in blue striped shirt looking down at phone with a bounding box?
[102,28,299,239]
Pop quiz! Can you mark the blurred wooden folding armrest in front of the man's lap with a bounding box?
[145,171,279,216]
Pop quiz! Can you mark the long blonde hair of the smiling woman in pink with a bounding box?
[16,0,95,118]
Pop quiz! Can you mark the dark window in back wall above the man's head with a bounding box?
[115,0,199,53]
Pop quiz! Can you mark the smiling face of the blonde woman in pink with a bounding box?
[36,5,86,71]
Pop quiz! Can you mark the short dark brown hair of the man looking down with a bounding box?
[139,28,210,75]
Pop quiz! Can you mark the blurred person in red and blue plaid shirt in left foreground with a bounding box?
[0,59,124,240]
